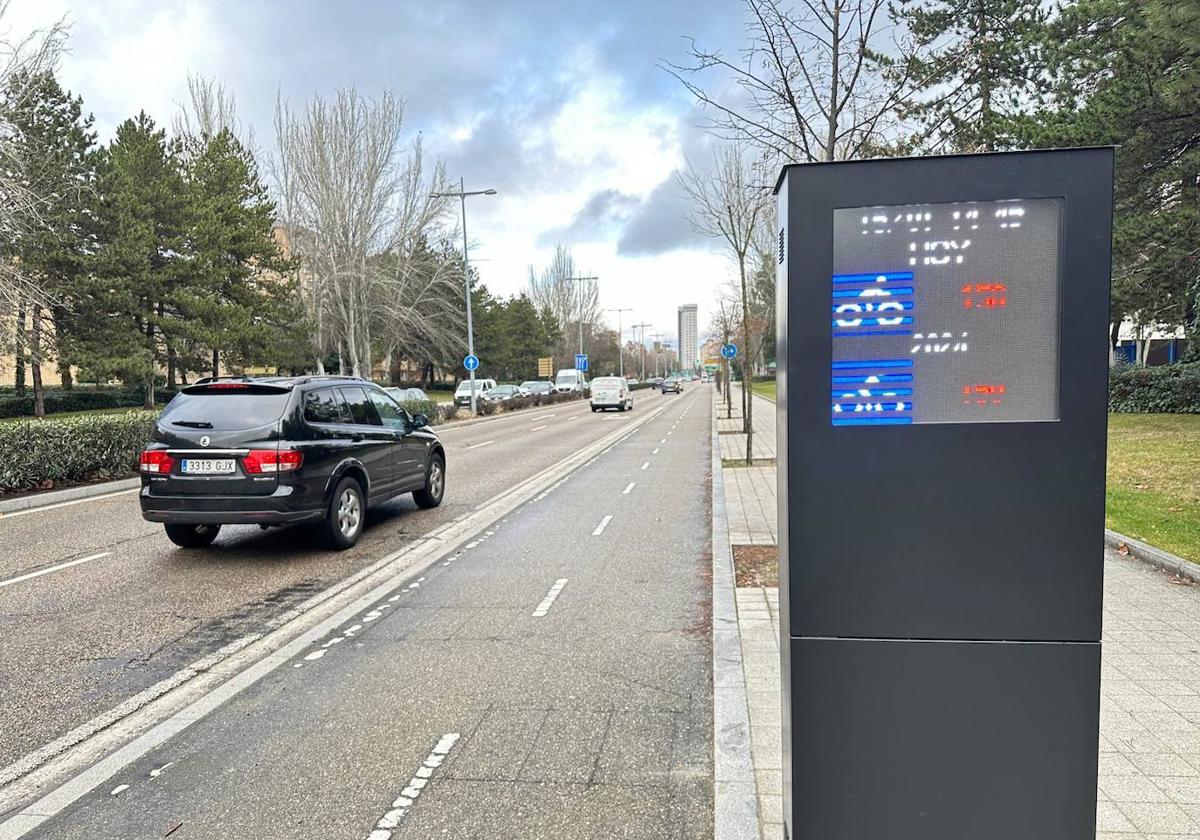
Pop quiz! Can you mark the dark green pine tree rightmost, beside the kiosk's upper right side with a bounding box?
[1021,0,1200,356]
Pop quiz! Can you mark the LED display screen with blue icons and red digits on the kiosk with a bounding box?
[830,198,1062,426]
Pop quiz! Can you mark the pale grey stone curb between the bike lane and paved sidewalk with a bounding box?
[710,396,761,840]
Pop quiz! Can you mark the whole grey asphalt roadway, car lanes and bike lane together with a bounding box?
[0,388,712,840]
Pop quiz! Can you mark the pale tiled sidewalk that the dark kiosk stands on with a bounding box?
[724,384,1200,840]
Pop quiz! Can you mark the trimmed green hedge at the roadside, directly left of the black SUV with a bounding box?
[0,412,158,493]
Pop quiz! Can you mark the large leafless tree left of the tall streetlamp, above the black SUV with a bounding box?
[275,88,461,376]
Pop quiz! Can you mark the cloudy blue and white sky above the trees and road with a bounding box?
[5,0,744,357]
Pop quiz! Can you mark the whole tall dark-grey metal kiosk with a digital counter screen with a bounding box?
[775,149,1112,840]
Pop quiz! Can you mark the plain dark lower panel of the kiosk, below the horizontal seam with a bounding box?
[784,638,1100,840]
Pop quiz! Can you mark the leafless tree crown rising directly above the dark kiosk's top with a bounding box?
[661,0,913,163]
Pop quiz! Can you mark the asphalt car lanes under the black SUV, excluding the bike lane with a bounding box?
[0,394,648,768]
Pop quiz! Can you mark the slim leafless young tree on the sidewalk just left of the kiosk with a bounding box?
[679,143,770,464]
